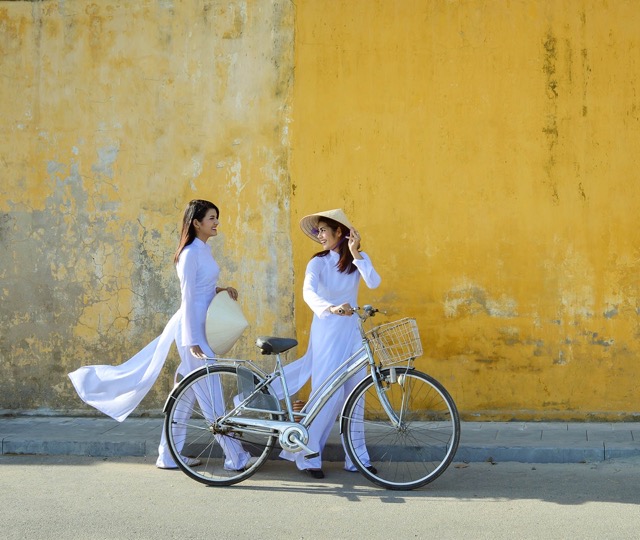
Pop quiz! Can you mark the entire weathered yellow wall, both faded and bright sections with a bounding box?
[0,0,640,419]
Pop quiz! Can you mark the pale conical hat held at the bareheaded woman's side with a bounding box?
[205,291,249,355]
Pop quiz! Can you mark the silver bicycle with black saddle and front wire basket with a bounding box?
[164,306,460,490]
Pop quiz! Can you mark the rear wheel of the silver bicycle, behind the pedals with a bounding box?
[164,365,280,486]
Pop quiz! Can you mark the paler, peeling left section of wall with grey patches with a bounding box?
[0,0,294,410]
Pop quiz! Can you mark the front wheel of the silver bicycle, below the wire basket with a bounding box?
[341,367,460,490]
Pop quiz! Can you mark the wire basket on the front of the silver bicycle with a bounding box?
[366,319,422,366]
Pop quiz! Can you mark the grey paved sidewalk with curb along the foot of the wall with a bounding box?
[0,416,640,463]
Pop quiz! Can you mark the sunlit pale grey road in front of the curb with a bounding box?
[0,455,640,540]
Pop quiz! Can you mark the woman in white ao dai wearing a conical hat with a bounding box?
[281,209,380,478]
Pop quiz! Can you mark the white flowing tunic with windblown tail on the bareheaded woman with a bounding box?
[69,238,220,422]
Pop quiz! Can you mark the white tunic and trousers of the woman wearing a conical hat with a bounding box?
[281,251,381,470]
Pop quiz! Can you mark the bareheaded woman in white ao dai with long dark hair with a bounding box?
[69,199,250,469]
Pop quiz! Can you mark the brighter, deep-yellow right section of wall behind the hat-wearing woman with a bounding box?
[291,0,640,419]
